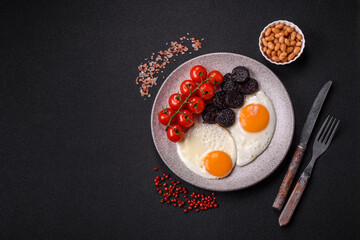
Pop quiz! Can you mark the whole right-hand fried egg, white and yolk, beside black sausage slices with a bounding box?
[228,91,276,166]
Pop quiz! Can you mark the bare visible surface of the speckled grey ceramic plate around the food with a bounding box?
[151,53,295,191]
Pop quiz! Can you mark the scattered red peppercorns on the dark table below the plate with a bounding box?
[154,167,219,213]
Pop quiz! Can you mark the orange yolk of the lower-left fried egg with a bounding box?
[204,151,233,177]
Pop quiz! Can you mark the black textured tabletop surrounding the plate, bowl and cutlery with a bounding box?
[0,0,360,239]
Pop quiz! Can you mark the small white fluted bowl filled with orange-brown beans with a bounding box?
[259,20,305,65]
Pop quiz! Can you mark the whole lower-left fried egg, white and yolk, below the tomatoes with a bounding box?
[177,122,237,179]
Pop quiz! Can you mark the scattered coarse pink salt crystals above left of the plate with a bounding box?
[135,33,204,97]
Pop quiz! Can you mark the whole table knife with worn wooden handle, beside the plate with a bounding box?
[272,81,332,210]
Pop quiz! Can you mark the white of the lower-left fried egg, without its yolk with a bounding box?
[177,122,237,179]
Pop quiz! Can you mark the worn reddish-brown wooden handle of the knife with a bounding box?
[273,146,305,210]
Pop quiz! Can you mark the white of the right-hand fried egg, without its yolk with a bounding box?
[228,91,276,166]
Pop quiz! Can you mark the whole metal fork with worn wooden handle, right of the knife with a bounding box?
[279,115,340,226]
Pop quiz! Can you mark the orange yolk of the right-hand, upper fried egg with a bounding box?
[239,103,270,132]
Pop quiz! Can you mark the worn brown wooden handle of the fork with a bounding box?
[279,172,310,226]
